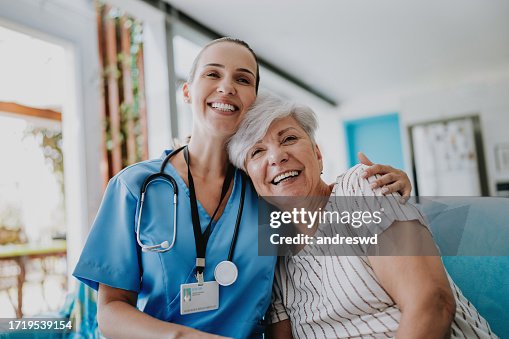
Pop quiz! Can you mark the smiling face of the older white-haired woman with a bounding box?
[246,116,324,197]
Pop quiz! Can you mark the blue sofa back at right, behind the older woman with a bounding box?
[421,197,509,338]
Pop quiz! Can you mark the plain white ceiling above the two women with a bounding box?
[166,0,509,102]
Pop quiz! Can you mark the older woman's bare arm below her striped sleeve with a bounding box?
[369,221,456,339]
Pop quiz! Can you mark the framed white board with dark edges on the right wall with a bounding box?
[408,115,488,196]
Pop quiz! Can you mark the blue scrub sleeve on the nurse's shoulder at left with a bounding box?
[73,176,141,292]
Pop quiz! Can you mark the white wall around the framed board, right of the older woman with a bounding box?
[339,67,509,195]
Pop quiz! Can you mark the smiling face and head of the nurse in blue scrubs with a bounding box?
[183,41,257,137]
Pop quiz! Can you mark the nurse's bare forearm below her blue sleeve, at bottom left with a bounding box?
[97,284,230,339]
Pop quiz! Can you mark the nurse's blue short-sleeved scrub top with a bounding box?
[73,151,276,338]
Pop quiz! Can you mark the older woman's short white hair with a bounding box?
[228,92,318,171]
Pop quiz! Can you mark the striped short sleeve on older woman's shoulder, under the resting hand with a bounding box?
[333,165,427,233]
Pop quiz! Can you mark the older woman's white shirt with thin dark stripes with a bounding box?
[268,165,497,338]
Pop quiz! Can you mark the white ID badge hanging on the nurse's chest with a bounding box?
[180,281,219,314]
